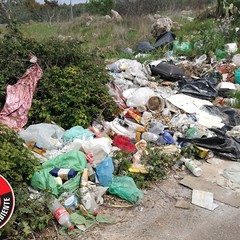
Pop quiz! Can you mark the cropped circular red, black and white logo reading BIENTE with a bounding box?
[0,175,15,228]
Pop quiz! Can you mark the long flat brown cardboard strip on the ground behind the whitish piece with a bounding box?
[180,175,240,207]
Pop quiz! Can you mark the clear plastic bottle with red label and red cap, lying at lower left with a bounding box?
[50,199,74,231]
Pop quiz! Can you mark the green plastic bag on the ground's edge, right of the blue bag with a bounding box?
[108,176,143,204]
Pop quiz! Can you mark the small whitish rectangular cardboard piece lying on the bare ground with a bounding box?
[192,189,218,211]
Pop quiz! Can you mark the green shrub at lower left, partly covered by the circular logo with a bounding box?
[0,124,52,239]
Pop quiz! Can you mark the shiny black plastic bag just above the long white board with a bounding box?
[178,78,218,100]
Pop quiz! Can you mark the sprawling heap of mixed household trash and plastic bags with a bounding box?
[0,19,240,234]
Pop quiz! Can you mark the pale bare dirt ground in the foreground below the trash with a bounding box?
[35,159,240,240]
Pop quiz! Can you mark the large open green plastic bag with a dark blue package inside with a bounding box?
[30,150,87,196]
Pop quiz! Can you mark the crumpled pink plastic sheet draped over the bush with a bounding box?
[0,63,43,130]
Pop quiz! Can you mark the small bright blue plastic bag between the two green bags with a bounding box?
[96,157,114,187]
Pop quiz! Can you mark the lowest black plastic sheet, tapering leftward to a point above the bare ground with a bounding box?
[178,136,240,162]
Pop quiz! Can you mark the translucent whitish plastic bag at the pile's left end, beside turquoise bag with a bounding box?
[18,123,64,149]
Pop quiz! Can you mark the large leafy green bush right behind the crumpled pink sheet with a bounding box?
[0,23,116,128]
